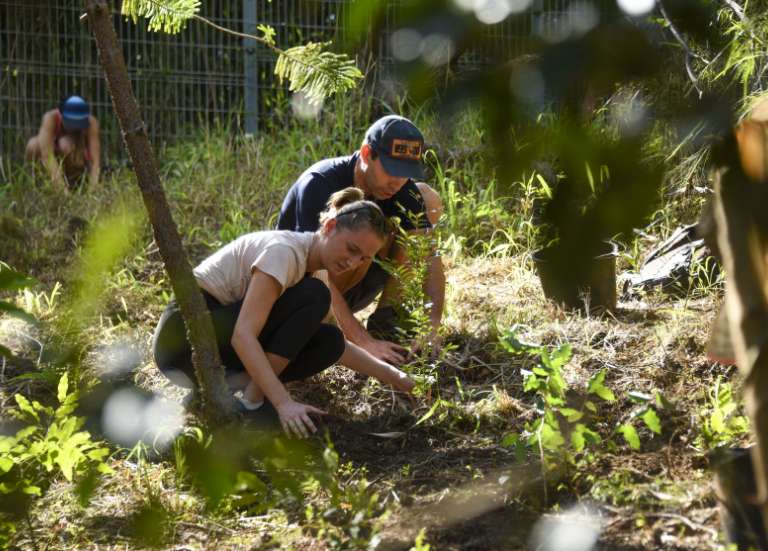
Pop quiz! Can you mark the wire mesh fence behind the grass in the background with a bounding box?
[0,0,567,163]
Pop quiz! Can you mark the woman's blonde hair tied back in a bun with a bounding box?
[320,187,392,239]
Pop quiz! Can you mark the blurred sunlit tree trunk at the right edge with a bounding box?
[715,122,768,544]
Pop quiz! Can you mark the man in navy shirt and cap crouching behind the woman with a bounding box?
[277,115,445,363]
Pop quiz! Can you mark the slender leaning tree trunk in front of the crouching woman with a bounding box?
[85,0,235,425]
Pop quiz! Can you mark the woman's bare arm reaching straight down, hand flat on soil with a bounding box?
[232,270,324,436]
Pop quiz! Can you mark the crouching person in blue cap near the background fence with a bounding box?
[26,96,101,190]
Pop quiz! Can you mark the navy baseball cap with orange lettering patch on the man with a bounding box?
[365,115,424,179]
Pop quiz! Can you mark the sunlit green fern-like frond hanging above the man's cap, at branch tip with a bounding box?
[275,42,363,104]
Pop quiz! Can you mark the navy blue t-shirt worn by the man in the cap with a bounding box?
[277,152,431,231]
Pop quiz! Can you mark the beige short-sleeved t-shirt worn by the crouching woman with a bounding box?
[194,231,315,304]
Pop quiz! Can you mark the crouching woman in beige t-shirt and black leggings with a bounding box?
[153,188,414,436]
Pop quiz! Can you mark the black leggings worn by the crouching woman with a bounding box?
[152,276,345,388]
